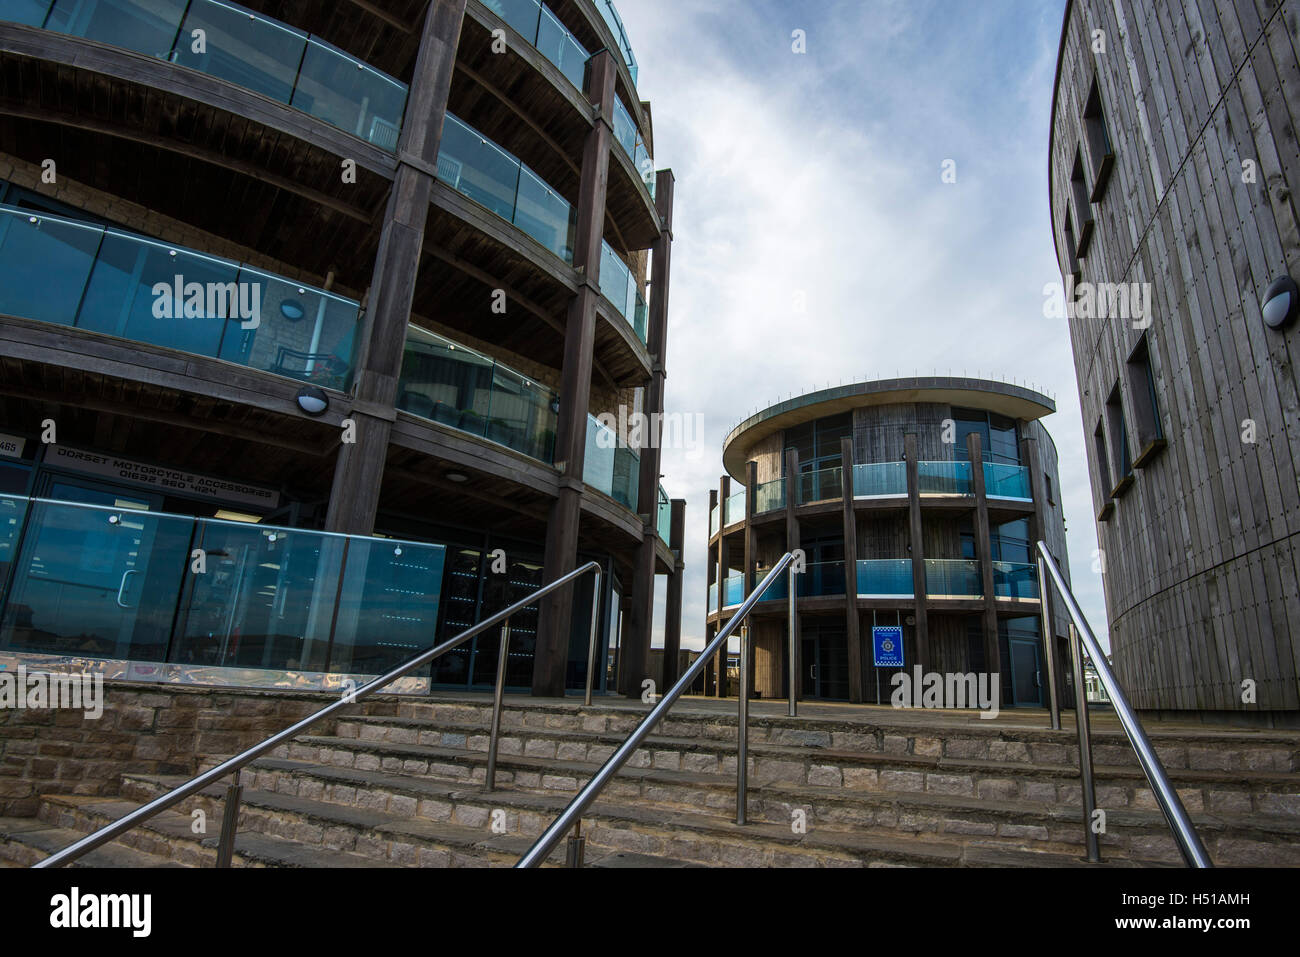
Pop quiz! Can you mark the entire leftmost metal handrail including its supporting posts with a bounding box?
[33,562,601,867]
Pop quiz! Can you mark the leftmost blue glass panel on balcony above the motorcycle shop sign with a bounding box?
[0,209,104,325]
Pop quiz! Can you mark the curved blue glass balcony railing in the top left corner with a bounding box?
[8,0,407,152]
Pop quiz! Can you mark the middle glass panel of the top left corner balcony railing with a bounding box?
[172,0,305,103]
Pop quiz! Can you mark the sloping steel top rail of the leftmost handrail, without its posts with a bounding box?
[33,562,601,867]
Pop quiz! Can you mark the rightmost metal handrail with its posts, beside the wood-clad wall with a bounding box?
[1037,541,1214,867]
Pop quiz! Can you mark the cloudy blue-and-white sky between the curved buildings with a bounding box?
[618,0,1106,649]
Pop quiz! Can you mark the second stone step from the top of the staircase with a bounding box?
[276,737,1300,817]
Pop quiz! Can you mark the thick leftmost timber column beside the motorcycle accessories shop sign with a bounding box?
[325,0,465,534]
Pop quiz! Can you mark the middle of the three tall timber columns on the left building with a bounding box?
[533,49,627,697]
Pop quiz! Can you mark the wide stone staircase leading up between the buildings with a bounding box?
[0,698,1300,867]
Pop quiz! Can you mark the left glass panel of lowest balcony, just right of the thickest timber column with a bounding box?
[398,326,494,436]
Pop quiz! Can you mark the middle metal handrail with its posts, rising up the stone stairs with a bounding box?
[515,551,794,867]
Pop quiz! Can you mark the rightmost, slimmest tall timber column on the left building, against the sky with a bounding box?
[620,169,673,698]
